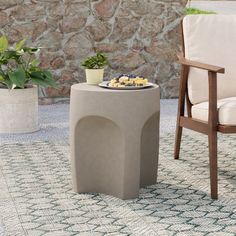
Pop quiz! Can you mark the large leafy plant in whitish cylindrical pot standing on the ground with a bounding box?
[0,36,57,133]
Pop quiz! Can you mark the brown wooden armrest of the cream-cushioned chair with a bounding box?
[177,55,225,74]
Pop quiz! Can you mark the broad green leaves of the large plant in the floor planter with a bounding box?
[0,36,57,89]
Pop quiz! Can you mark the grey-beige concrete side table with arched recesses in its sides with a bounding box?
[70,84,160,199]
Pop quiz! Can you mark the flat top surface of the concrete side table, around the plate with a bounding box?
[71,83,159,93]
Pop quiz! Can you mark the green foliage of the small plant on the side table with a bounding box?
[81,52,109,69]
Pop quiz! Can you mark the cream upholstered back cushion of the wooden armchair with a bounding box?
[183,15,236,104]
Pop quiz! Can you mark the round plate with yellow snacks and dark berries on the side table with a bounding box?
[99,74,153,90]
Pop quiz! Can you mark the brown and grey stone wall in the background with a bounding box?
[0,0,186,101]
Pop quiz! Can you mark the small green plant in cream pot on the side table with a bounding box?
[81,52,109,84]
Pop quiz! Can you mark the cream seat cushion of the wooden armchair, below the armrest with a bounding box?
[192,97,236,126]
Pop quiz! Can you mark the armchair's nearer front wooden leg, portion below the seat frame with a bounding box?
[208,131,218,199]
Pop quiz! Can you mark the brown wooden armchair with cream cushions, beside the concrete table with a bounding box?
[174,15,236,199]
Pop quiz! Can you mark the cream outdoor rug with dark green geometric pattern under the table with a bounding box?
[0,133,236,236]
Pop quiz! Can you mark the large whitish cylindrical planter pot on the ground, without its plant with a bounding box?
[0,87,39,134]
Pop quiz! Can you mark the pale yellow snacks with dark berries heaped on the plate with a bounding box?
[108,75,148,88]
